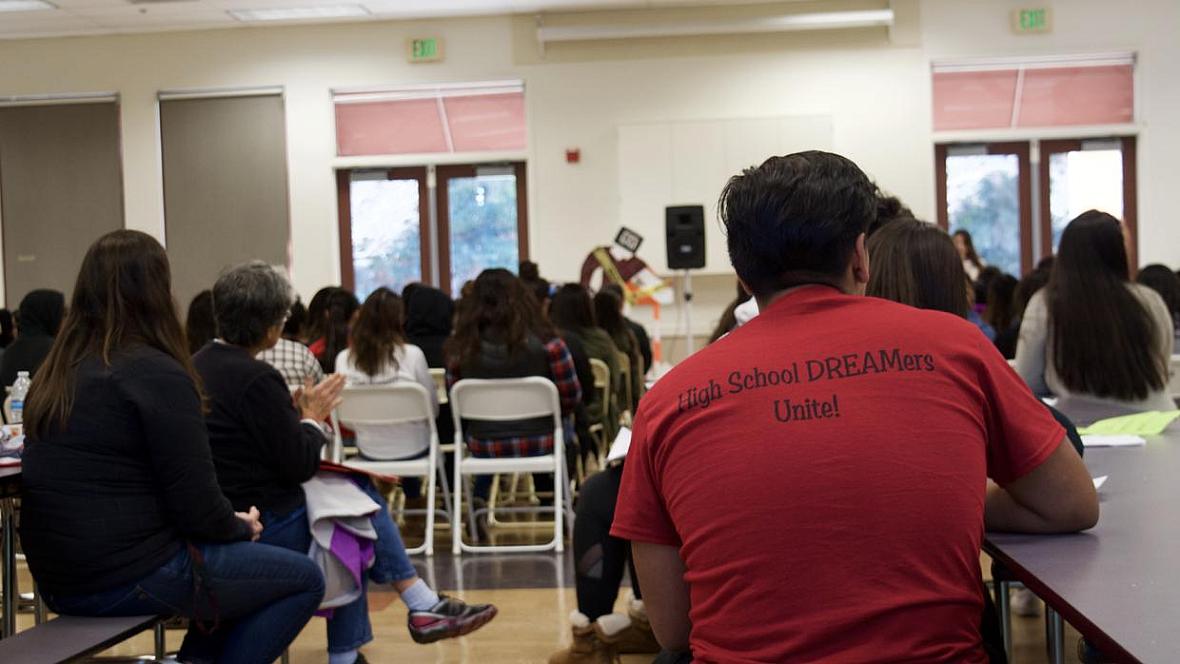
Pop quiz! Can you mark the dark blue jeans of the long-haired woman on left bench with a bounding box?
[45,543,323,664]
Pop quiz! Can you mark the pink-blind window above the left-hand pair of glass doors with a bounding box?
[333,81,526,157]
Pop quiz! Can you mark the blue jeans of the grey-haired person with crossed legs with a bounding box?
[261,480,418,652]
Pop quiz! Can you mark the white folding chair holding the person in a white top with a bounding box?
[332,382,454,555]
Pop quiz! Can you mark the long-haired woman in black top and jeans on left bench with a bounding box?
[20,230,323,664]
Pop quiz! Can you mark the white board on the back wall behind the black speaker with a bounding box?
[618,116,832,272]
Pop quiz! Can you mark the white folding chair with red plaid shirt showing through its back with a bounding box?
[451,376,569,555]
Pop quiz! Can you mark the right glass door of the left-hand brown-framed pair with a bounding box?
[435,162,529,297]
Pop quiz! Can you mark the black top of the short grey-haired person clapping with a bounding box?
[194,342,327,515]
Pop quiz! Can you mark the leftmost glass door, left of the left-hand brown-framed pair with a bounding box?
[337,166,431,301]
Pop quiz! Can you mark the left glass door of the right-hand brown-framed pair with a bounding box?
[935,143,1033,276]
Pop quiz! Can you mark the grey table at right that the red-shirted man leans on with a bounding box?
[984,407,1180,663]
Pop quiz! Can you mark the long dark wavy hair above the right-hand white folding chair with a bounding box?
[444,268,555,363]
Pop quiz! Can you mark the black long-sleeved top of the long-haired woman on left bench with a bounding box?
[20,347,250,596]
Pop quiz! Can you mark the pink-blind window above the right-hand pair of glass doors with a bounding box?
[933,63,1135,131]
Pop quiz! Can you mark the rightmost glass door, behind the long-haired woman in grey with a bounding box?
[1040,137,1136,265]
